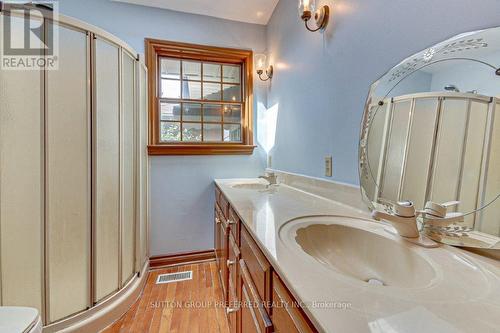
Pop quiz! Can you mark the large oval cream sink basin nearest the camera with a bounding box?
[285,216,436,288]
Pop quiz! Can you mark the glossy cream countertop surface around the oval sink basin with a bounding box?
[215,179,500,333]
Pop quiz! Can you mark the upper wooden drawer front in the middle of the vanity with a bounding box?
[240,227,272,307]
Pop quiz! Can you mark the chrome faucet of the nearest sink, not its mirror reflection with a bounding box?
[372,201,420,238]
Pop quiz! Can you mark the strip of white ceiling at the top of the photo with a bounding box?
[113,0,279,25]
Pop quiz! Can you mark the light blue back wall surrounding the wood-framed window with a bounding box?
[60,0,266,255]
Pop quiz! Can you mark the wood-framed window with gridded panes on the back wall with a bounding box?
[146,39,255,155]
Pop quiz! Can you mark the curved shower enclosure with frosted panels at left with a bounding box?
[0,7,148,332]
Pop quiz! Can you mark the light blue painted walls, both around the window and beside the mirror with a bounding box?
[61,0,500,255]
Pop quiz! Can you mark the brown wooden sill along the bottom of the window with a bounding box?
[148,144,256,156]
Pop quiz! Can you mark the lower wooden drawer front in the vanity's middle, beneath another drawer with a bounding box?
[239,259,273,333]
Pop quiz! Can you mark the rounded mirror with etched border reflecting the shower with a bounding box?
[360,28,500,249]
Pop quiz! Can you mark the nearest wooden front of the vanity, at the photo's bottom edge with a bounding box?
[272,273,317,333]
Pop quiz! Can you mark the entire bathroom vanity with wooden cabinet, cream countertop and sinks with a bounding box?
[214,174,500,332]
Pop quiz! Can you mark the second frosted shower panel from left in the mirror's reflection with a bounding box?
[381,101,411,201]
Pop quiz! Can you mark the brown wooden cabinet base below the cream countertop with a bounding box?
[215,184,317,333]
